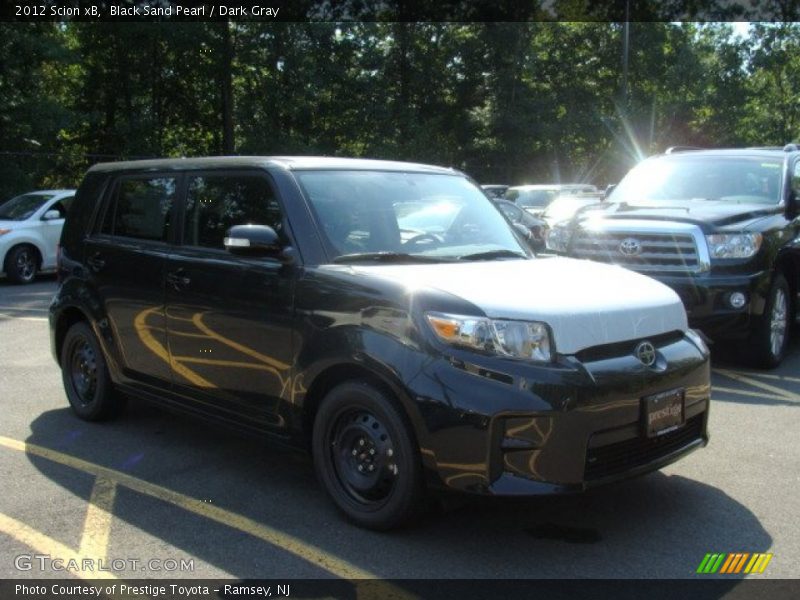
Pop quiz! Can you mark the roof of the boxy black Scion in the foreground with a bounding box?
[89,156,461,175]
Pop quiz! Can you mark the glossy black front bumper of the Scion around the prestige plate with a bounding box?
[412,334,710,496]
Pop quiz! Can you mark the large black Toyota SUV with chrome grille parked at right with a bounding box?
[547,144,800,367]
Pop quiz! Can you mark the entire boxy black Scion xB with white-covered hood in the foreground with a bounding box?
[50,157,710,528]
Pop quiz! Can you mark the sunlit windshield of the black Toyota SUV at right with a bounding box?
[610,153,783,204]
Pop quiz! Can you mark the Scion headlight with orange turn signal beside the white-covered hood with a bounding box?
[425,313,553,362]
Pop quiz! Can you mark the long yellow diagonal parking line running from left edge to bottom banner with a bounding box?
[0,436,382,580]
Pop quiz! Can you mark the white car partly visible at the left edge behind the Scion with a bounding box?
[0,190,75,283]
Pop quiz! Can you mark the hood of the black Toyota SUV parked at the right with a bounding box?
[580,200,782,228]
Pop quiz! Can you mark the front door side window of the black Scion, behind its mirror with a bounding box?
[183,174,283,250]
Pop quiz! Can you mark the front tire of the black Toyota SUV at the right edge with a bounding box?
[743,273,792,369]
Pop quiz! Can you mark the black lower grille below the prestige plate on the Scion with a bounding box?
[584,413,704,481]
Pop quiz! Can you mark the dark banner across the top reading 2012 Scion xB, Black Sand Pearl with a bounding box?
[0,0,800,22]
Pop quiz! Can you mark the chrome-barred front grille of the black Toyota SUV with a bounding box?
[571,229,701,272]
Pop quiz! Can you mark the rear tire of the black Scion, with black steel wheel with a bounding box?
[61,322,125,421]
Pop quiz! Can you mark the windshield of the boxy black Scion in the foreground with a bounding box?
[296,170,528,260]
